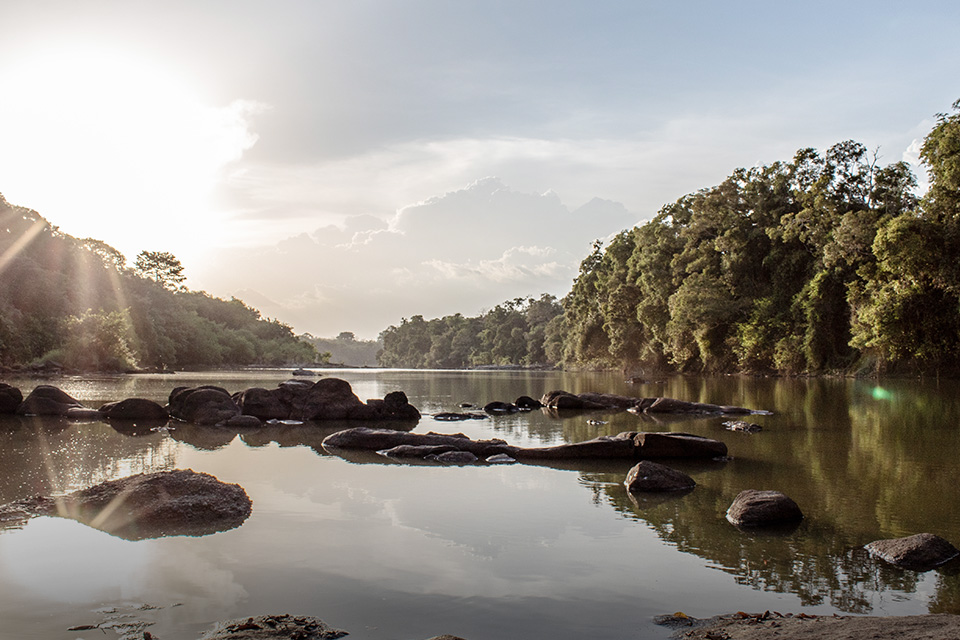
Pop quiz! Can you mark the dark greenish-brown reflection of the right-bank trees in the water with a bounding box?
[563,378,960,613]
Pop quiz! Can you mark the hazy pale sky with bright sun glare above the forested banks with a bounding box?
[0,0,960,338]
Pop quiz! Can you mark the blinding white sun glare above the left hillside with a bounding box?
[0,42,260,268]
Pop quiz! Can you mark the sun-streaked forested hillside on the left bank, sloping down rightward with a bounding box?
[0,196,316,371]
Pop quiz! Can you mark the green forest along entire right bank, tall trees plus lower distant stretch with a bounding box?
[381,101,960,373]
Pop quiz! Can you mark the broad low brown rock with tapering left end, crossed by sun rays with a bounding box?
[0,469,251,540]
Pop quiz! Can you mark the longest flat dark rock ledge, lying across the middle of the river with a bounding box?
[323,427,727,461]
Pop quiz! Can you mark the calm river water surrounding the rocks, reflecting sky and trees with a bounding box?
[0,370,960,640]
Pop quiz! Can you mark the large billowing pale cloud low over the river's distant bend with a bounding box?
[195,177,636,337]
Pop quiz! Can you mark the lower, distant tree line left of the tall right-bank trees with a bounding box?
[378,294,563,369]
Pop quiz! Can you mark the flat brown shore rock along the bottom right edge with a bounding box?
[669,612,960,640]
